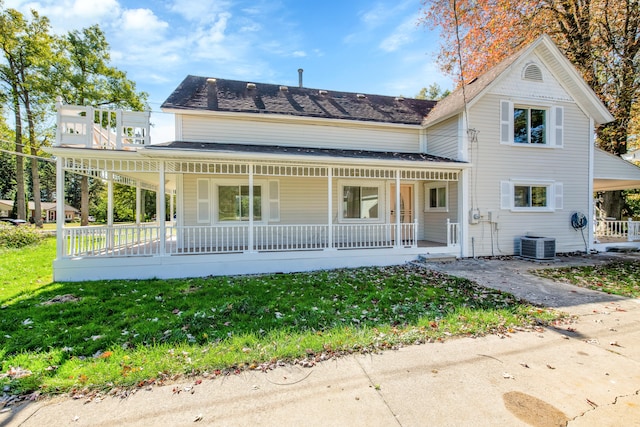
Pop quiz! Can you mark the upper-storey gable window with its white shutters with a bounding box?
[500,101,564,148]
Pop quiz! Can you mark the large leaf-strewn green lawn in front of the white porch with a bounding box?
[0,239,559,393]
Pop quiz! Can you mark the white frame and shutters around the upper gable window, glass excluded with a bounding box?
[499,100,564,148]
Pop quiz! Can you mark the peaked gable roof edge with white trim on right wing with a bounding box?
[423,35,613,126]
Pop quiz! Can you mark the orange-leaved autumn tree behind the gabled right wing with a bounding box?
[422,0,640,217]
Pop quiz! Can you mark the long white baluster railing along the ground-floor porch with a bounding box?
[64,223,436,257]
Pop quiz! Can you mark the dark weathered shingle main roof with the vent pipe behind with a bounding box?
[162,75,436,125]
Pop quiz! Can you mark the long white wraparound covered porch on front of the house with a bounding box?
[47,147,463,281]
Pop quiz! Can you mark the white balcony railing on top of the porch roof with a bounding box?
[55,102,151,150]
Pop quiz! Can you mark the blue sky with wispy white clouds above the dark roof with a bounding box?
[5,0,453,142]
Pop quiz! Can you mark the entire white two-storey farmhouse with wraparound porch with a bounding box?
[49,36,640,280]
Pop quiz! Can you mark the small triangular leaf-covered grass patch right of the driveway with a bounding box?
[532,261,640,298]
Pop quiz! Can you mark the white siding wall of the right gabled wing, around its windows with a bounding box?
[464,84,590,256]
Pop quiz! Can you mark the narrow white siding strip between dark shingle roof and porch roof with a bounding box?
[179,115,420,153]
